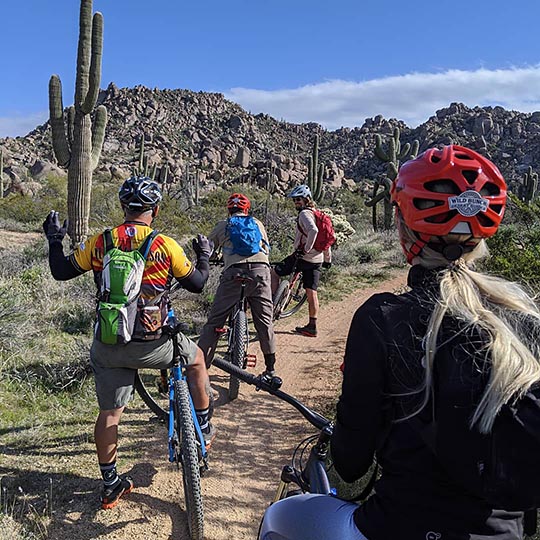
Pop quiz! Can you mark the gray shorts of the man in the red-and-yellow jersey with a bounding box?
[90,334,197,410]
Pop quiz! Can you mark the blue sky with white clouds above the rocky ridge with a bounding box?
[0,0,540,137]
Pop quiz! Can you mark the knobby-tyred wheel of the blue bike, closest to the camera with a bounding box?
[174,380,204,540]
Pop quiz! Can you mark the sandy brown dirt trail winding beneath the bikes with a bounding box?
[40,272,405,540]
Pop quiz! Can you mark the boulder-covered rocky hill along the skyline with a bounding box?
[0,83,540,196]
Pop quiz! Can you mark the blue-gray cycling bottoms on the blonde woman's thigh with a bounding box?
[259,493,367,540]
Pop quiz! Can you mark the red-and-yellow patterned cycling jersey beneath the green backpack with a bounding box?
[70,223,194,304]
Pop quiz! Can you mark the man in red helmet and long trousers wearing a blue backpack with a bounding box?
[198,193,276,376]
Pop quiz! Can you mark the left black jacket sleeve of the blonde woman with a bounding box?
[331,295,387,482]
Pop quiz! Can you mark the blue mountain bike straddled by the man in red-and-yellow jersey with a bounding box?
[135,318,208,540]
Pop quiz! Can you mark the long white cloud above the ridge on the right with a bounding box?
[226,65,540,129]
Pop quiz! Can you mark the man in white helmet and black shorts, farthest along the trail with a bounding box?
[272,185,332,337]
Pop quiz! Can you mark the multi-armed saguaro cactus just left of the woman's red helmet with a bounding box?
[365,127,420,231]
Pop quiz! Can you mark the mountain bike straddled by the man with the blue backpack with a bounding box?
[216,274,255,401]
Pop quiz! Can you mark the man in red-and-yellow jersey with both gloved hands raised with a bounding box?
[43,177,215,509]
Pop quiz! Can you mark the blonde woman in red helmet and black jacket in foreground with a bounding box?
[260,146,540,540]
